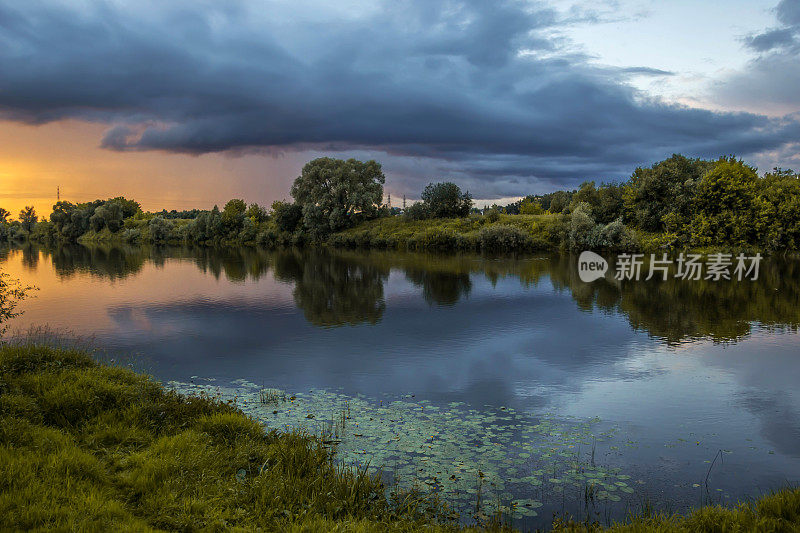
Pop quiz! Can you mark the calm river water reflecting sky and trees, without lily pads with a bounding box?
[0,242,800,526]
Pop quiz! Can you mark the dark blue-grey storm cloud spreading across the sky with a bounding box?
[0,0,800,191]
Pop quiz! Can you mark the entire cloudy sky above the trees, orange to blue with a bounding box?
[0,0,800,214]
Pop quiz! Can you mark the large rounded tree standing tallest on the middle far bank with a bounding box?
[292,157,386,237]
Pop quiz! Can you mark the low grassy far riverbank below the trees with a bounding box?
[54,214,771,255]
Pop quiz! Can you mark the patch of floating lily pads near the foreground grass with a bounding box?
[168,380,634,518]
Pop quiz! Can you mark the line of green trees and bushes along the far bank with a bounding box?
[0,154,800,251]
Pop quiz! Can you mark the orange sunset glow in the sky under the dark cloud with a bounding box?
[0,120,302,218]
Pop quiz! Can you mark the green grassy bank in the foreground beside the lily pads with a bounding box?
[0,346,800,531]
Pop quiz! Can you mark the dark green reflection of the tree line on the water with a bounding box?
[0,245,800,345]
